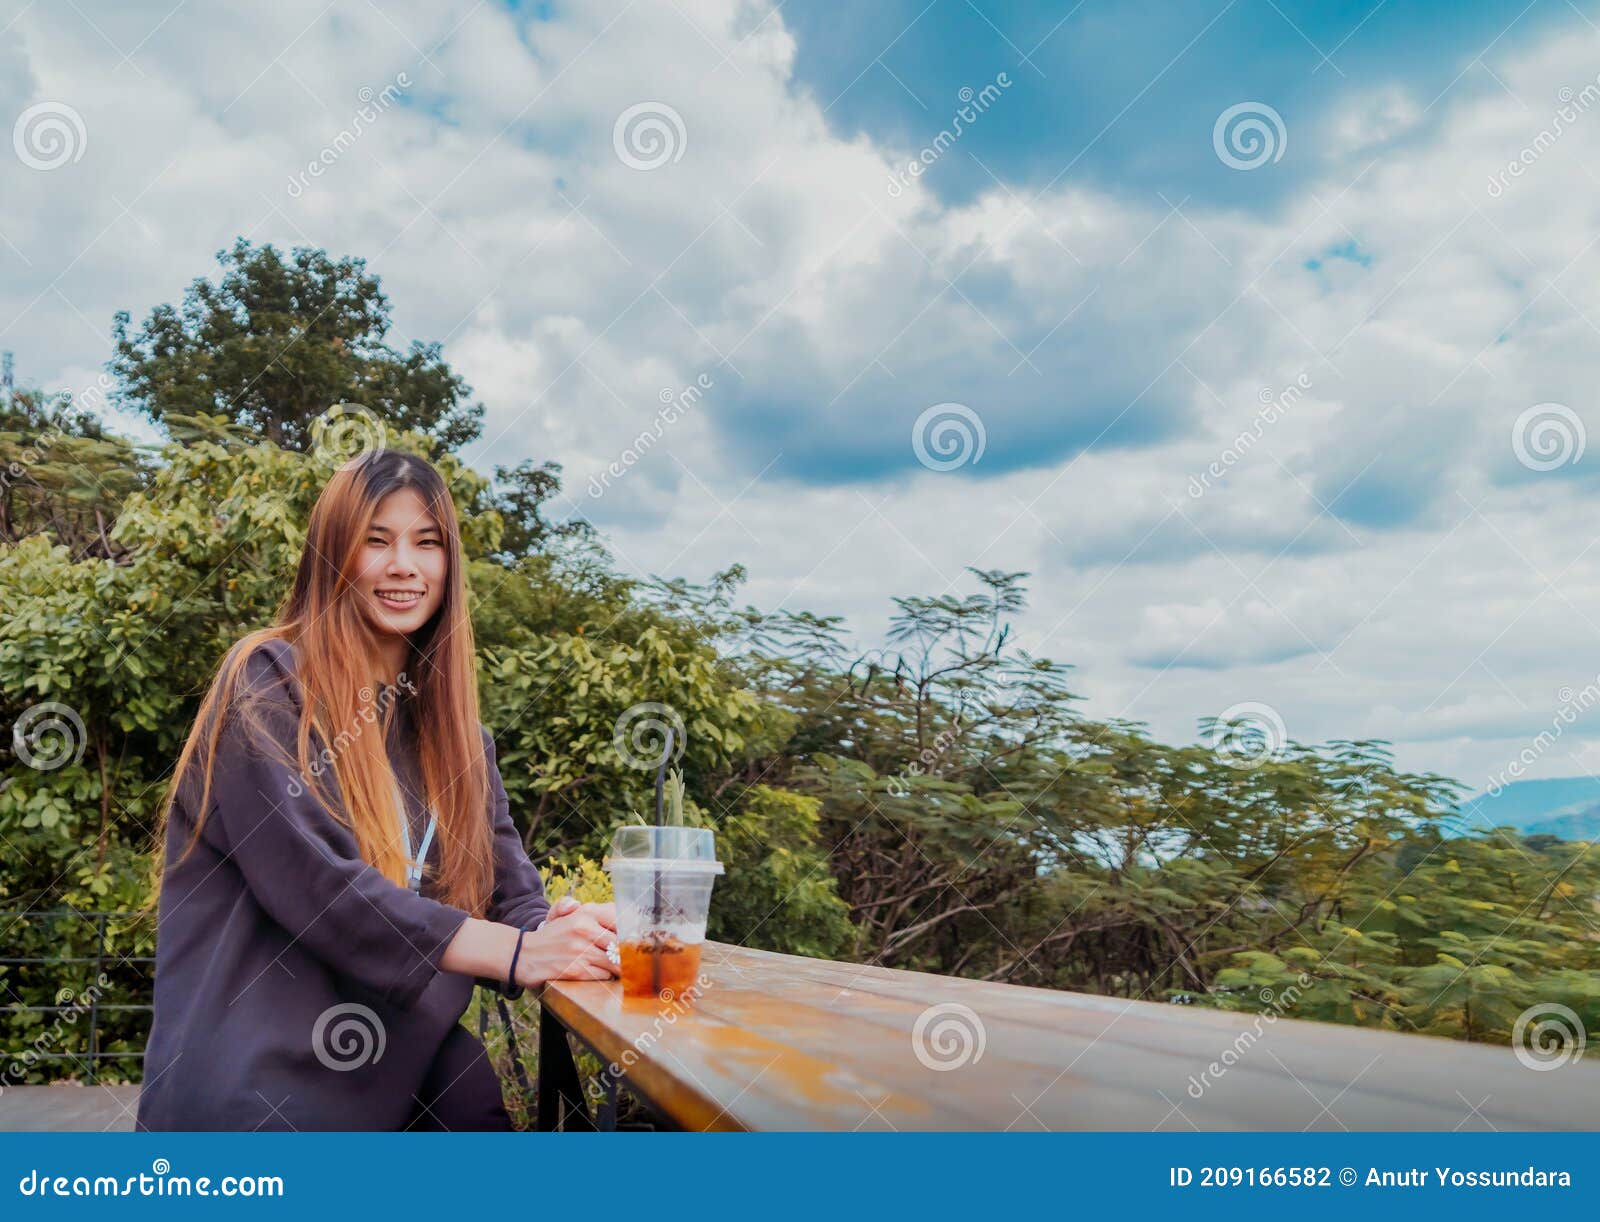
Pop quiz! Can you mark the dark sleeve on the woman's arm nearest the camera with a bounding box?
[206,649,467,1006]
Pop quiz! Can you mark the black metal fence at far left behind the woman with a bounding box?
[0,909,155,1083]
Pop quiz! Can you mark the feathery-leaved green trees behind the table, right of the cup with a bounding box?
[694,569,1600,1041]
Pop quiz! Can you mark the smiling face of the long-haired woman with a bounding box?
[355,488,450,637]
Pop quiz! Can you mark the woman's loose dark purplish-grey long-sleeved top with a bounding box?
[138,641,549,1131]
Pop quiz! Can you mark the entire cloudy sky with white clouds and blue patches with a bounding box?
[0,0,1600,787]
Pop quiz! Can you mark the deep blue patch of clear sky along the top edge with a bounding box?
[784,0,1576,208]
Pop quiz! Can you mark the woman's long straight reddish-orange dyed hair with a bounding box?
[152,449,494,917]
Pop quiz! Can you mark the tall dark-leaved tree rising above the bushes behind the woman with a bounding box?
[110,238,483,449]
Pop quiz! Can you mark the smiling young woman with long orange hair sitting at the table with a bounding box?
[138,449,616,1129]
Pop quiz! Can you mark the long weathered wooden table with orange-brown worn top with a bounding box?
[539,942,1600,1132]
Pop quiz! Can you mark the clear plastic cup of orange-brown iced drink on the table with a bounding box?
[605,825,722,1001]
